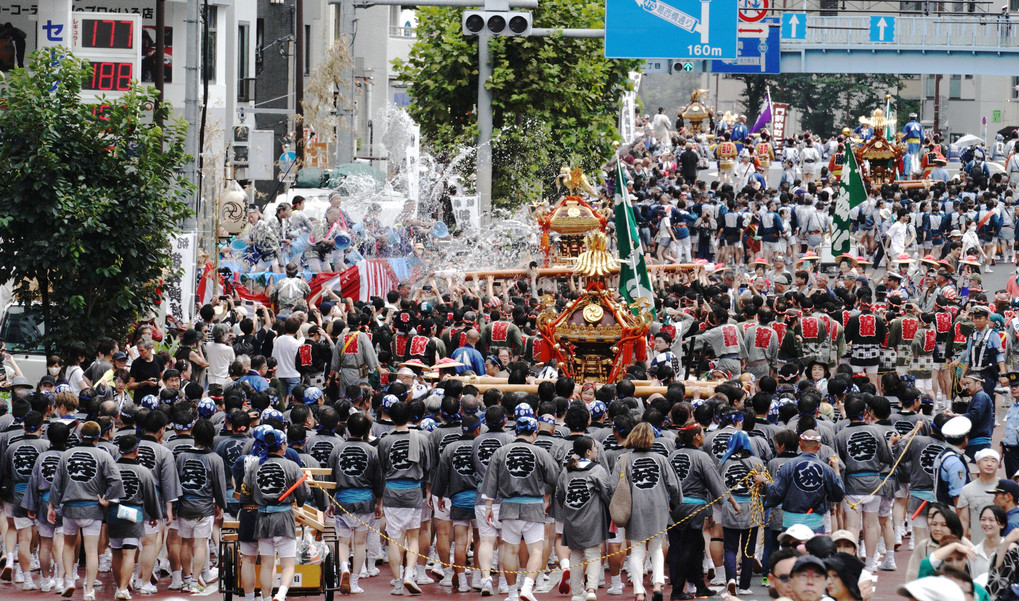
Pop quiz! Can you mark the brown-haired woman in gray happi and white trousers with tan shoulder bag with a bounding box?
[611,422,683,595]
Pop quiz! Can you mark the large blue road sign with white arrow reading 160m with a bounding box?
[605,0,739,60]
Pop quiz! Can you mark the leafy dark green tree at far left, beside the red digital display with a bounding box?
[0,50,194,351]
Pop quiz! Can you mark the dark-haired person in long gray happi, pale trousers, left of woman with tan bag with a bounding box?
[555,438,612,597]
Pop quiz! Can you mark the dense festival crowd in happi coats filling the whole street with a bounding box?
[0,116,1019,601]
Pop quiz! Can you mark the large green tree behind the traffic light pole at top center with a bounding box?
[395,0,639,207]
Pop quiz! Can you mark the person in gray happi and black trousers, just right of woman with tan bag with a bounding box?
[668,422,735,598]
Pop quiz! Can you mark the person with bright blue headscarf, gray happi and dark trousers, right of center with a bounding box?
[719,431,765,592]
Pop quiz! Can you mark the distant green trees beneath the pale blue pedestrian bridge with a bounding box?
[733,73,917,135]
